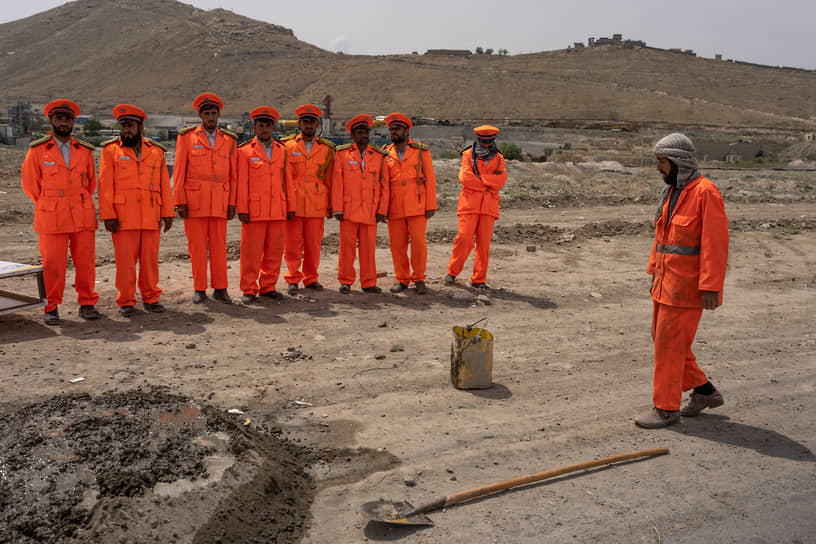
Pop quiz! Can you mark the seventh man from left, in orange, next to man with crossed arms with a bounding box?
[385,112,436,295]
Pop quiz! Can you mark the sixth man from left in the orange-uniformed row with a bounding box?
[332,114,389,295]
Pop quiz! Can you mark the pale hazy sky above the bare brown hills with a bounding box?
[0,0,816,69]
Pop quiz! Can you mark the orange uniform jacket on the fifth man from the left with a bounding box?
[283,135,334,217]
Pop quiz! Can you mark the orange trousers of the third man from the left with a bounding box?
[184,217,228,291]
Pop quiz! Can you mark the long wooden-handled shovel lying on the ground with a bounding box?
[360,448,669,525]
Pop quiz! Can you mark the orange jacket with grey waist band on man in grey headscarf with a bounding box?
[646,176,728,308]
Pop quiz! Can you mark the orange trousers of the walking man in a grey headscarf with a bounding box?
[652,302,708,410]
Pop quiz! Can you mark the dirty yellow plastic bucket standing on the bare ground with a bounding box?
[451,319,493,389]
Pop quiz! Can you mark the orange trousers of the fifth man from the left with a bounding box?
[283,217,324,285]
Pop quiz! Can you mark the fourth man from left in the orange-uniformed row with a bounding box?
[237,106,295,304]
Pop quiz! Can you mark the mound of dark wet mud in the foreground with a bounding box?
[0,390,313,543]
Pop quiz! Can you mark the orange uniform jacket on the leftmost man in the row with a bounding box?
[23,134,97,234]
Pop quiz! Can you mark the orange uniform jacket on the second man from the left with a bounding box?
[99,138,175,230]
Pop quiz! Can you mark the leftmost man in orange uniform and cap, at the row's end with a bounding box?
[22,98,99,325]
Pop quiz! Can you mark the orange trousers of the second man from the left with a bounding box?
[111,229,161,306]
